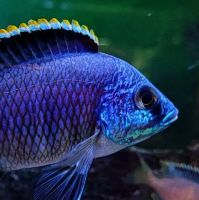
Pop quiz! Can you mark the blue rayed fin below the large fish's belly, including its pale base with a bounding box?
[33,130,98,200]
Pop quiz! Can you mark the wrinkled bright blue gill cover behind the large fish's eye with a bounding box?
[100,88,131,144]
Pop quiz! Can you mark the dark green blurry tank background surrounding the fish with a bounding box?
[0,0,199,200]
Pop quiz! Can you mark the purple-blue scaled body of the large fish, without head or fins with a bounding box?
[0,53,117,170]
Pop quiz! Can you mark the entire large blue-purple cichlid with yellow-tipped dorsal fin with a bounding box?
[0,18,178,200]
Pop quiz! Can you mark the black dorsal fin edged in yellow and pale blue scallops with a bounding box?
[0,18,98,69]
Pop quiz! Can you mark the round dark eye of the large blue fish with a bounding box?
[135,87,157,109]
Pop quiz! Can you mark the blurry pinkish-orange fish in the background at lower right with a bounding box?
[134,158,199,200]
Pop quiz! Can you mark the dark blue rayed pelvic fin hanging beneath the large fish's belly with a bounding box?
[33,163,90,200]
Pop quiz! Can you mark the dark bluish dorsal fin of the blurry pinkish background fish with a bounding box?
[161,161,199,183]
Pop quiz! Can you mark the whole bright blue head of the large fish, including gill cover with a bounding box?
[100,59,178,146]
